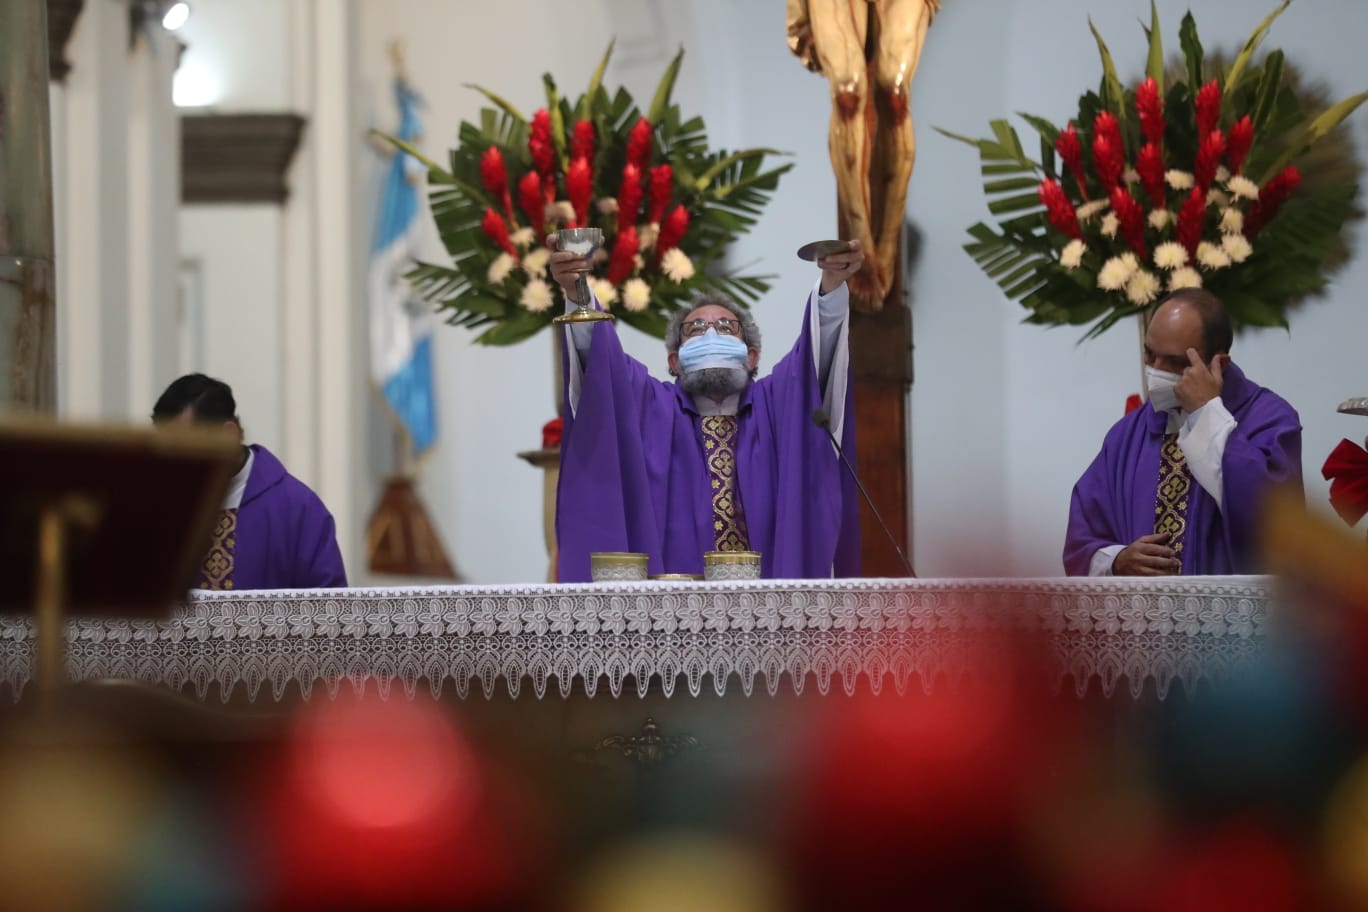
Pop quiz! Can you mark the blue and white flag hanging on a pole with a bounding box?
[368,79,436,455]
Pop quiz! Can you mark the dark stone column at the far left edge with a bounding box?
[0,0,56,412]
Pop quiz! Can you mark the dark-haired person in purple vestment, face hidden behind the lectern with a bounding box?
[152,373,346,589]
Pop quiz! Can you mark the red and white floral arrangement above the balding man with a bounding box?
[941,0,1368,338]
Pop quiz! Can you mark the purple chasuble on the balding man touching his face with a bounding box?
[1064,362,1302,576]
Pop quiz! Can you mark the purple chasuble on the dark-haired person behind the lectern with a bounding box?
[201,444,346,589]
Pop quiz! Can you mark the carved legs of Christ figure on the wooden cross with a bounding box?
[788,0,941,310]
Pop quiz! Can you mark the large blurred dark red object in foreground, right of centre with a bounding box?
[788,631,1079,909]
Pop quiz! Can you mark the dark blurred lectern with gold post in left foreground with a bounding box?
[0,417,242,710]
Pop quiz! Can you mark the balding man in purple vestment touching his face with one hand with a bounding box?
[1064,289,1302,576]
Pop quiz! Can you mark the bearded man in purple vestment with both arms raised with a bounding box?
[547,235,865,582]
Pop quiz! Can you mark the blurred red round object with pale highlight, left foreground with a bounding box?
[254,696,536,909]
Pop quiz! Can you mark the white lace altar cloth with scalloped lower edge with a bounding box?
[0,577,1274,701]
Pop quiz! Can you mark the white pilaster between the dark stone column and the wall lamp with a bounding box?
[51,3,181,423]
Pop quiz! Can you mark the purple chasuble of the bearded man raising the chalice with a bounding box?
[555,297,859,582]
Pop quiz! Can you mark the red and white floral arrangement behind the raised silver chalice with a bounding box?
[390,44,792,345]
